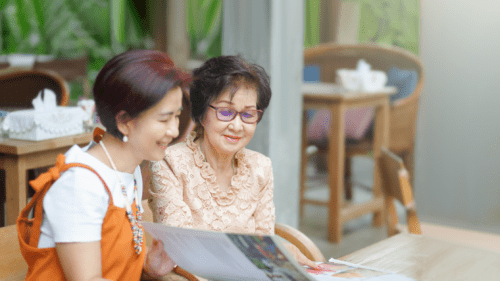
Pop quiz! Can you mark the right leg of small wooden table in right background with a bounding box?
[373,100,389,226]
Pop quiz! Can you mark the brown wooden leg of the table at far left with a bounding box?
[4,157,27,225]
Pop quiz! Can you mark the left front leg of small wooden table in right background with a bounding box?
[328,102,345,243]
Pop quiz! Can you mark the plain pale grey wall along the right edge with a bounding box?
[414,0,500,232]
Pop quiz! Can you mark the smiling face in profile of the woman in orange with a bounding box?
[127,87,182,161]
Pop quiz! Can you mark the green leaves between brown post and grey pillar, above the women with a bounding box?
[186,0,222,60]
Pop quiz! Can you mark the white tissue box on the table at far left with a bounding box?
[2,106,88,141]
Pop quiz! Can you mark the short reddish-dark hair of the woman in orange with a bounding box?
[93,50,190,139]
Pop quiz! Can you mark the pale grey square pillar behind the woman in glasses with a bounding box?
[222,0,304,227]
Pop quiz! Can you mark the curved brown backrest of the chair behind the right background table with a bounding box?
[304,43,424,153]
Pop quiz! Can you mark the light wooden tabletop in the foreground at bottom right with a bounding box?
[340,233,500,281]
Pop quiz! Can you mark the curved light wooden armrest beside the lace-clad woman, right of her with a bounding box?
[274,223,326,262]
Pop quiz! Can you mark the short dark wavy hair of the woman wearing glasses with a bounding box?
[190,56,271,129]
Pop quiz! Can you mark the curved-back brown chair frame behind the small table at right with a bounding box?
[304,43,424,199]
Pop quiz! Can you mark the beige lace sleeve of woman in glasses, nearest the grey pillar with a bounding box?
[255,161,275,234]
